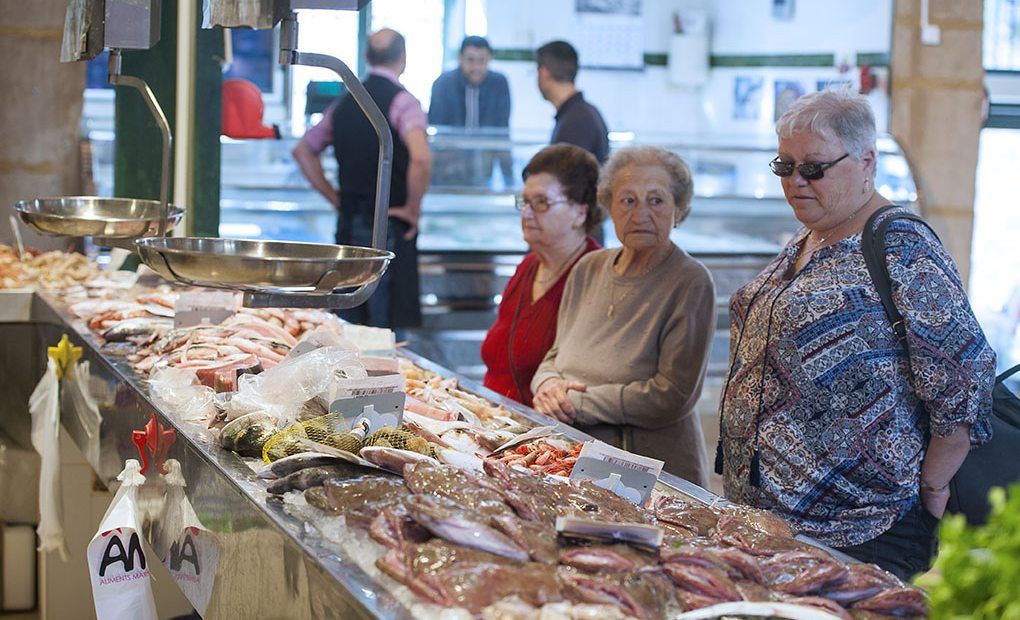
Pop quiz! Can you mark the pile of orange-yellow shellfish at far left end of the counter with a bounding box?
[0,244,99,290]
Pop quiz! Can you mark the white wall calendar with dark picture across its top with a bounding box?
[574,0,645,69]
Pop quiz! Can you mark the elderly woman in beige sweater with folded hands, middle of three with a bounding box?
[531,147,715,485]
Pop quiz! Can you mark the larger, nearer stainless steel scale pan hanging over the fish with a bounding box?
[135,237,394,295]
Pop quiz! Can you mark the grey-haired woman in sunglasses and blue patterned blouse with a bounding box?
[716,91,995,577]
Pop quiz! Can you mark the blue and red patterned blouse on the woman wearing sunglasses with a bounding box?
[720,205,996,547]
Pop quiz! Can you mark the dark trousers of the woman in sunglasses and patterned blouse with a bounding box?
[835,501,938,581]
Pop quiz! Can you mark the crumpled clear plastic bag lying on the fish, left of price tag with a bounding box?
[222,347,368,426]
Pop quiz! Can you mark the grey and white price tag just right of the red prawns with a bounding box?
[570,442,663,506]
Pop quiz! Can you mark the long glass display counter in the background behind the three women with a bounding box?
[220,127,918,377]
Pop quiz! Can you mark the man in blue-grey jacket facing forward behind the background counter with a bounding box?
[428,37,510,130]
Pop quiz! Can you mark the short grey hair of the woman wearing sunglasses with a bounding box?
[775,89,876,159]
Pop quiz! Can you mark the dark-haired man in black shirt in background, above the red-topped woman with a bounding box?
[537,41,609,163]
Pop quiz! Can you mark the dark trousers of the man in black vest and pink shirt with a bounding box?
[337,198,421,329]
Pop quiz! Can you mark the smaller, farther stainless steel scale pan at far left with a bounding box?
[14,196,185,241]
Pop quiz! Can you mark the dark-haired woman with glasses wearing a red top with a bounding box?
[481,144,605,406]
